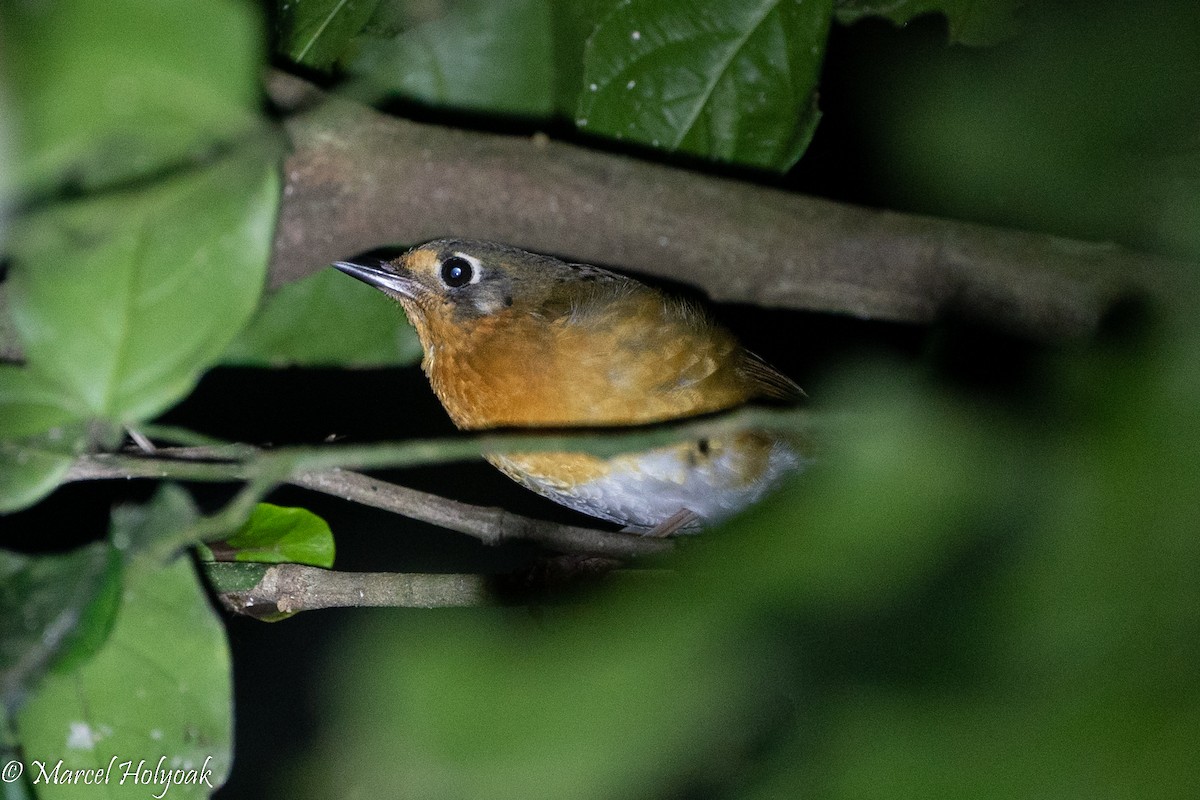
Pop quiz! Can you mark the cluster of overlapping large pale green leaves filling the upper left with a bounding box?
[0,2,278,509]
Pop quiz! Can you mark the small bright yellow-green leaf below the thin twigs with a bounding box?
[202,503,334,570]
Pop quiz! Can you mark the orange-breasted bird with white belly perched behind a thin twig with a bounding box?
[334,239,808,536]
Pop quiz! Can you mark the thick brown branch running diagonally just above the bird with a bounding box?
[269,72,1166,338]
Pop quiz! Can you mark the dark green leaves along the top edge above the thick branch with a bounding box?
[277,0,996,172]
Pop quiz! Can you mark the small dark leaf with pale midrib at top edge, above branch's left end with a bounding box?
[275,0,379,70]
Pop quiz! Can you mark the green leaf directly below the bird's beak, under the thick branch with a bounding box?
[222,269,421,367]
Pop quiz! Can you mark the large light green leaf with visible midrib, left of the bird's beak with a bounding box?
[10,143,278,425]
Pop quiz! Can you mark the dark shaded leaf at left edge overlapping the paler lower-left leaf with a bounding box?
[0,542,121,709]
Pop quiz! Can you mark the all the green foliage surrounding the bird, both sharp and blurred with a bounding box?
[0,0,1200,798]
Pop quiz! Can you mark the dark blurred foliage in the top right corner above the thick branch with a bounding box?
[859,2,1200,249]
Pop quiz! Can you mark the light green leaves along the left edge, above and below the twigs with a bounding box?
[0,0,267,798]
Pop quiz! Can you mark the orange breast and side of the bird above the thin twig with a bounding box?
[425,293,755,428]
